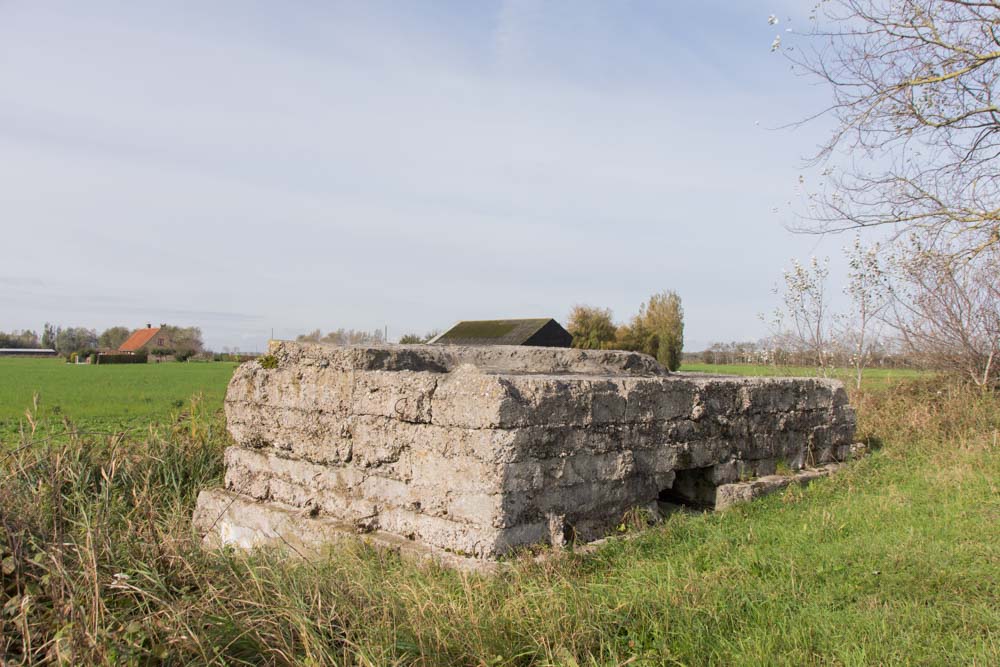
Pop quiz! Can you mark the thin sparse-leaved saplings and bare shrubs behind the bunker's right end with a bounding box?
[756,239,1000,387]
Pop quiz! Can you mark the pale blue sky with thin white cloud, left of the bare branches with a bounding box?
[0,0,850,351]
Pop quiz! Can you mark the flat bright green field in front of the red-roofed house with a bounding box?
[0,358,236,440]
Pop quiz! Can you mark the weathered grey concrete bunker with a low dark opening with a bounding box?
[196,342,854,559]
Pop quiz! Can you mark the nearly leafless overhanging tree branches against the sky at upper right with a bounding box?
[788,0,1000,256]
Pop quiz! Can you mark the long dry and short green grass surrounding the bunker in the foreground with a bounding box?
[0,362,1000,665]
